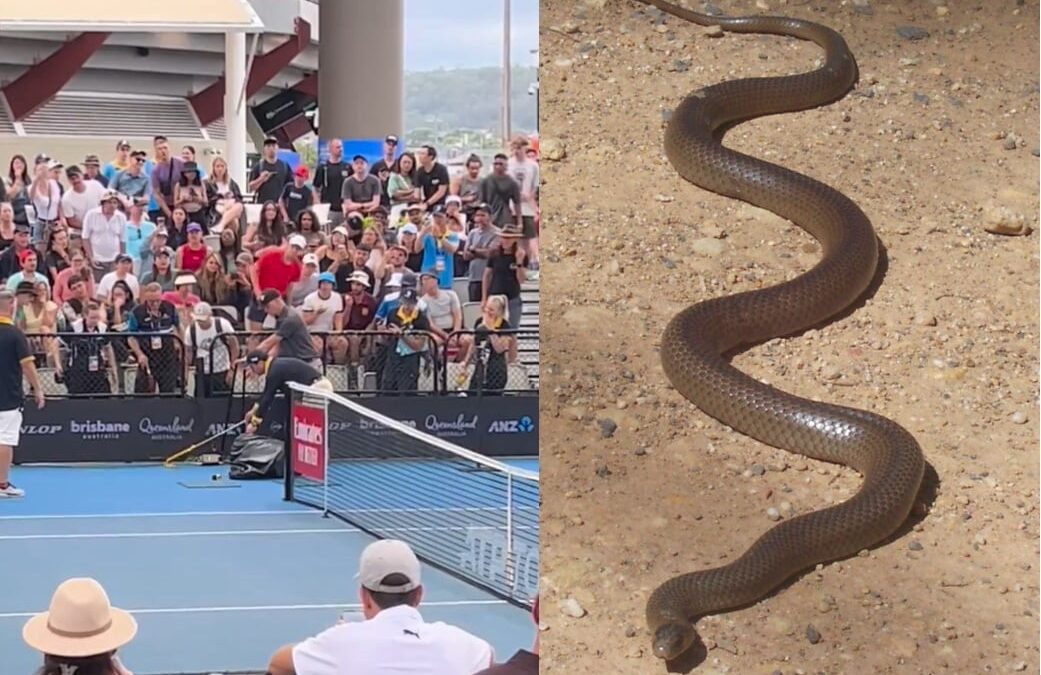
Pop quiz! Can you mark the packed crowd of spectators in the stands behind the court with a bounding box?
[0,135,539,395]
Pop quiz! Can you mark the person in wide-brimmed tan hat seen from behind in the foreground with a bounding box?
[22,578,137,675]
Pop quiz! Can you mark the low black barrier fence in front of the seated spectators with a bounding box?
[21,329,538,399]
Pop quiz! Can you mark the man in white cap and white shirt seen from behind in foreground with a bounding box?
[268,540,494,675]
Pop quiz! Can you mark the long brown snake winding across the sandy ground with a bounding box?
[640,0,924,658]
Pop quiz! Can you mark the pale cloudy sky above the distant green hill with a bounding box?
[405,0,538,71]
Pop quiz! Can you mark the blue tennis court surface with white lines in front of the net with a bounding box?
[0,459,538,675]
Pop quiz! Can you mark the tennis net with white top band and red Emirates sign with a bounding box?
[285,384,539,606]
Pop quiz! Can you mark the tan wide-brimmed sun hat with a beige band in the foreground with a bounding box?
[22,578,137,657]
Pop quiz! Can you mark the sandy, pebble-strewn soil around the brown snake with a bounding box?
[540,0,1039,675]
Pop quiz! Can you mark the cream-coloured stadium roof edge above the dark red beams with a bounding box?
[0,0,263,33]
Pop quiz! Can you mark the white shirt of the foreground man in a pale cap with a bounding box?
[293,605,494,675]
